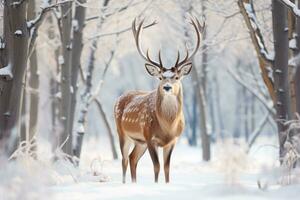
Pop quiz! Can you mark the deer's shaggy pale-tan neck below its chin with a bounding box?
[156,86,183,126]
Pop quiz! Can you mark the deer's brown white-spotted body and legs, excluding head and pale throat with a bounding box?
[115,81,184,182]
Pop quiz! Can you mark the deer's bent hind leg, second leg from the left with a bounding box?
[129,144,147,182]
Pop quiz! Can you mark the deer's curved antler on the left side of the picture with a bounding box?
[132,19,164,70]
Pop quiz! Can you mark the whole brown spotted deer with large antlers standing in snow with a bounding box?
[114,18,205,183]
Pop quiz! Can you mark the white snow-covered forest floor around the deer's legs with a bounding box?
[0,138,300,200]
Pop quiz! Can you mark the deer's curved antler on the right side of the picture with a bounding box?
[174,18,205,68]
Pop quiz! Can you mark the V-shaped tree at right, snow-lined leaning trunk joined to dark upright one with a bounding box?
[238,0,292,158]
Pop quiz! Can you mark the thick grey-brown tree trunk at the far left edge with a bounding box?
[0,0,29,154]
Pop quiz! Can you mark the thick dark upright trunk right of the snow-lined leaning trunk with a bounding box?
[272,0,290,158]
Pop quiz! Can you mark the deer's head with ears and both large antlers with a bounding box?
[132,18,205,95]
